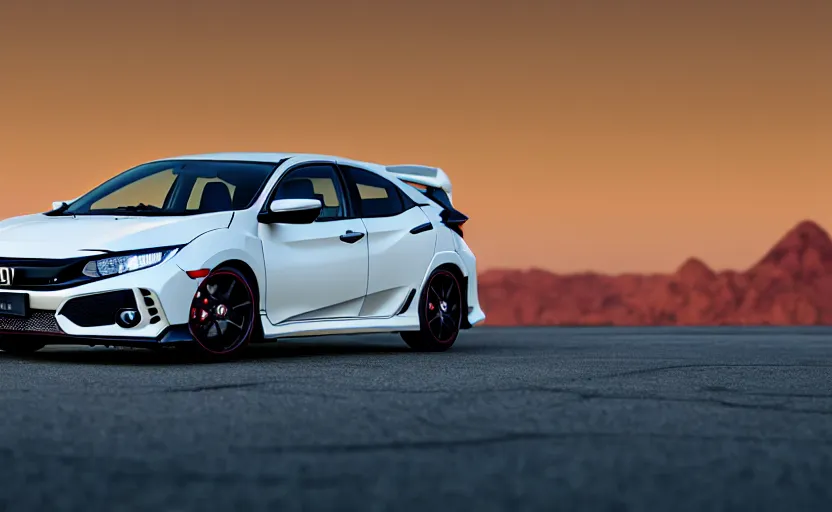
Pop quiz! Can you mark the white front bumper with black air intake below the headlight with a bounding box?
[0,260,198,344]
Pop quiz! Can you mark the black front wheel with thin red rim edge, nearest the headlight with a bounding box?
[188,267,262,360]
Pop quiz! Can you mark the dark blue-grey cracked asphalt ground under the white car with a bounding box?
[0,328,832,512]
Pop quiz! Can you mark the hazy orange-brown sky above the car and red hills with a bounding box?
[0,0,832,272]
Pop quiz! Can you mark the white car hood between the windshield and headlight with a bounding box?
[0,212,233,259]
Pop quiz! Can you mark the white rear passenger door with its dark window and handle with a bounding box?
[340,165,437,318]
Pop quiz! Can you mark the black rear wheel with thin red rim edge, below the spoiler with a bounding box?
[401,269,463,352]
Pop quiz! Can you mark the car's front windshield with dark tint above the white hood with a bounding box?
[60,160,277,216]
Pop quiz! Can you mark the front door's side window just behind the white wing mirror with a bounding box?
[272,165,346,220]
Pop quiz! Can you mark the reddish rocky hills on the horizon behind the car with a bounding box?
[479,221,832,325]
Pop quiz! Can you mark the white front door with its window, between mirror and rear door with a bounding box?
[259,164,368,325]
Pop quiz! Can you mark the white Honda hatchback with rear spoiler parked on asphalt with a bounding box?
[0,153,485,356]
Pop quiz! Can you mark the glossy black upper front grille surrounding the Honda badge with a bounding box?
[0,258,91,290]
